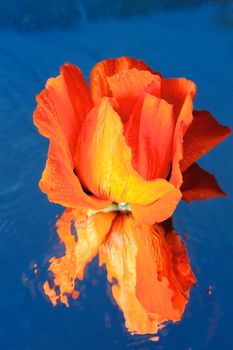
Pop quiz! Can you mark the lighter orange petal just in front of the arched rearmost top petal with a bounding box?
[106,68,161,121]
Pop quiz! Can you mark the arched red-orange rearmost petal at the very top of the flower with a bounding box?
[90,57,158,104]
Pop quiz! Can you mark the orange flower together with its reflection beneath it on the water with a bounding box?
[34,57,230,334]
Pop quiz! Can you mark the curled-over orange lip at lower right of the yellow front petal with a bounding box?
[131,187,182,225]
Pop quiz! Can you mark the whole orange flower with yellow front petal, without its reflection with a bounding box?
[34,57,230,224]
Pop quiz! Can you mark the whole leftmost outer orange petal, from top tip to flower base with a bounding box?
[33,64,109,208]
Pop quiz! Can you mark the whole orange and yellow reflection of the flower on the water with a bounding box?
[44,209,196,334]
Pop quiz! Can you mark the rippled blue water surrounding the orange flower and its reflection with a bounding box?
[0,4,233,350]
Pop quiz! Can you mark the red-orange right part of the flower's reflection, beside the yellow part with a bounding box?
[136,224,196,314]
